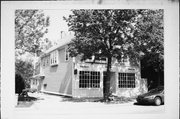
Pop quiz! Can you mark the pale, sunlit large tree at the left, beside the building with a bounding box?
[15,9,50,88]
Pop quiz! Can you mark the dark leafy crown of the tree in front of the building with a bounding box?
[65,10,137,60]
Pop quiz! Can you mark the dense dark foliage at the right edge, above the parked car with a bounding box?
[135,10,164,71]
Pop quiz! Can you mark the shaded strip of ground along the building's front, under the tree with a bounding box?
[62,97,134,104]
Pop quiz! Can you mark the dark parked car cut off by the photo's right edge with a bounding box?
[136,86,164,106]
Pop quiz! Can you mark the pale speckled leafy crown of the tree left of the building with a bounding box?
[15,10,49,53]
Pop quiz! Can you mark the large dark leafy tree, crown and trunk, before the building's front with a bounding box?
[65,9,163,100]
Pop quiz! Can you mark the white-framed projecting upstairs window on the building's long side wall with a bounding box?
[50,50,59,66]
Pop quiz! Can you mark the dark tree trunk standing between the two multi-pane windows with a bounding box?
[103,57,112,101]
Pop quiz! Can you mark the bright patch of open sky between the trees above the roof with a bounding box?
[43,9,71,44]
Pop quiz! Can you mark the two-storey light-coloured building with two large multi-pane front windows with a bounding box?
[32,44,147,97]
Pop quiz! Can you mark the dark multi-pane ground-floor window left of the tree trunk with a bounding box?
[79,71,100,88]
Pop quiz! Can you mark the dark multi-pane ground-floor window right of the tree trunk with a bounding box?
[118,73,135,88]
